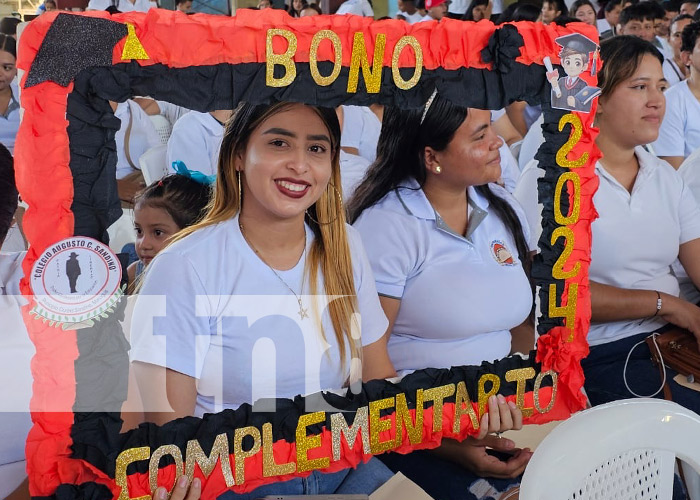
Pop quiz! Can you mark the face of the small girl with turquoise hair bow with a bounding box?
[134,205,180,266]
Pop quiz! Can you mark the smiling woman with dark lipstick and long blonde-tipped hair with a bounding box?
[131,103,395,498]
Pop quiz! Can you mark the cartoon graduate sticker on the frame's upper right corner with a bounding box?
[544,33,600,113]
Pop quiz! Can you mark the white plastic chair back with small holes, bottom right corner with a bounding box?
[520,398,700,500]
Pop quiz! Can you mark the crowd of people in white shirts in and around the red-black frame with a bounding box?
[0,0,700,500]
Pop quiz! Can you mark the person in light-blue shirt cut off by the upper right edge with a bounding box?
[652,22,700,168]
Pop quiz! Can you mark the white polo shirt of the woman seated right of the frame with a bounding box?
[515,147,700,345]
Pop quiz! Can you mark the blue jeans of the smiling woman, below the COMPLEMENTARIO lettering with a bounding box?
[219,458,393,500]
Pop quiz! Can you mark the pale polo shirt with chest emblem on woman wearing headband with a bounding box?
[355,180,532,373]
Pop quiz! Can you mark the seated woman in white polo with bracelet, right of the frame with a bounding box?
[516,36,700,412]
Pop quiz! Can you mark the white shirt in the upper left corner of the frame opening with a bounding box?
[114,99,161,179]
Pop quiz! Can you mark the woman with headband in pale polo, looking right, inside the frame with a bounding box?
[349,94,534,499]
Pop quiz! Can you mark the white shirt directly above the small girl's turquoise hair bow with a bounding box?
[167,111,224,175]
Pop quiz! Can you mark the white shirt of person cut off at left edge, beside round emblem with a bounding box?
[0,252,36,498]
